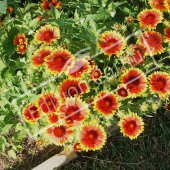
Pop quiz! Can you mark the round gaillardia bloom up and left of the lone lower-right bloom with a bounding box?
[94,91,119,116]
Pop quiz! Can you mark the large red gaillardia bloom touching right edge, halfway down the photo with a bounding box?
[149,71,170,95]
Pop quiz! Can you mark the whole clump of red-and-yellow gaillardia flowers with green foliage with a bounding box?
[0,0,170,158]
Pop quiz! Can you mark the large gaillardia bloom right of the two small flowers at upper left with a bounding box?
[35,25,60,44]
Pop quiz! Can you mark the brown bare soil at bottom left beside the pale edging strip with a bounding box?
[0,137,63,170]
